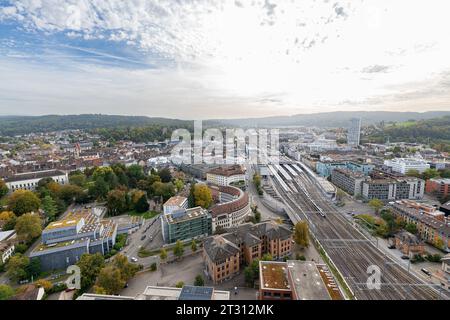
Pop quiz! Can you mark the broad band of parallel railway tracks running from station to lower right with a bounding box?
[268,162,448,300]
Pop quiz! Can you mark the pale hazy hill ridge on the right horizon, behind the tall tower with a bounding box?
[207,111,450,128]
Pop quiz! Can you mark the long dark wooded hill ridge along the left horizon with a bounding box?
[0,114,191,136]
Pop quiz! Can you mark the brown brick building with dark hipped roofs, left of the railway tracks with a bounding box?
[203,221,292,284]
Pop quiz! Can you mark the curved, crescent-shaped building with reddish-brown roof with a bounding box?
[210,186,251,233]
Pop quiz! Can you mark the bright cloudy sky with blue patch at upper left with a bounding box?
[0,0,450,119]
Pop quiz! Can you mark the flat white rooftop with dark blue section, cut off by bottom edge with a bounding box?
[77,286,230,301]
